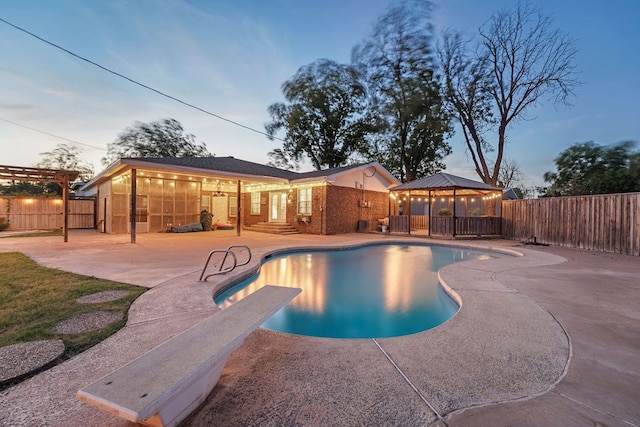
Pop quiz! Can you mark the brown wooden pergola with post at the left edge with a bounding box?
[0,165,80,242]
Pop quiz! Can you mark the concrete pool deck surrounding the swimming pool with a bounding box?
[0,231,640,426]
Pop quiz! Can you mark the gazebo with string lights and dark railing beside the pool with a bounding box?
[389,173,502,237]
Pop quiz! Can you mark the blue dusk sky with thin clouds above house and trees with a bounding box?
[0,0,640,185]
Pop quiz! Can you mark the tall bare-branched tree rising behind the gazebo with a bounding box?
[439,4,579,185]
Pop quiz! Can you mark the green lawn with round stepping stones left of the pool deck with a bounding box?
[0,252,146,370]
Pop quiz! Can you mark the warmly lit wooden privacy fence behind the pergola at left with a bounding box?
[0,197,95,230]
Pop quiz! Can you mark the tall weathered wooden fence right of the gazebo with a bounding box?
[502,193,640,256]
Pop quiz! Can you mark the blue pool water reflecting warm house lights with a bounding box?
[215,245,496,338]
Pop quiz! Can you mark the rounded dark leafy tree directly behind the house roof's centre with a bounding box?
[265,59,370,170]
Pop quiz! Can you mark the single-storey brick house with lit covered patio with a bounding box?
[82,157,400,234]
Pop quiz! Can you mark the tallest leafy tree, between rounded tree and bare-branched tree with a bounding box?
[352,2,451,182]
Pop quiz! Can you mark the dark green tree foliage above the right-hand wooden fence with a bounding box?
[544,141,640,197]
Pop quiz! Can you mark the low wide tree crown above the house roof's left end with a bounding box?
[102,119,211,165]
